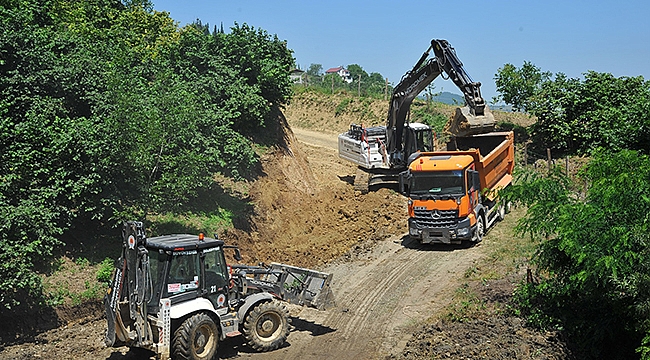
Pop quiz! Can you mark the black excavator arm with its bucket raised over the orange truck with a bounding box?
[386,39,495,167]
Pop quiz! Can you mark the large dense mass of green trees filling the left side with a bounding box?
[0,0,294,311]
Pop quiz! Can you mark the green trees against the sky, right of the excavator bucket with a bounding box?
[495,62,650,154]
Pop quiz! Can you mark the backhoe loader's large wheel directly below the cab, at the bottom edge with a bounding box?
[172,313,219,360]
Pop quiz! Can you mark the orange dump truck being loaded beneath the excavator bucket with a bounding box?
[400,131,514,244]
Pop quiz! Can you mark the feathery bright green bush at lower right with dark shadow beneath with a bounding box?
[504,150,650,358]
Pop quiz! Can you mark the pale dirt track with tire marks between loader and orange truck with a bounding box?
[233,236,483,360]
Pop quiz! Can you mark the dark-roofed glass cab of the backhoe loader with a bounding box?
[147,234,229,314]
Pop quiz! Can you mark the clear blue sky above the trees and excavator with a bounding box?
[153,0,650,102]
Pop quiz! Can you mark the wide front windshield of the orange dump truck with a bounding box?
[409,170,465,195]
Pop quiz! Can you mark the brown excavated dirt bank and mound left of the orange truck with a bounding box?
[223,114,406,267]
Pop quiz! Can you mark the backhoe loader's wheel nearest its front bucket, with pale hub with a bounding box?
[243,301,289,351]
